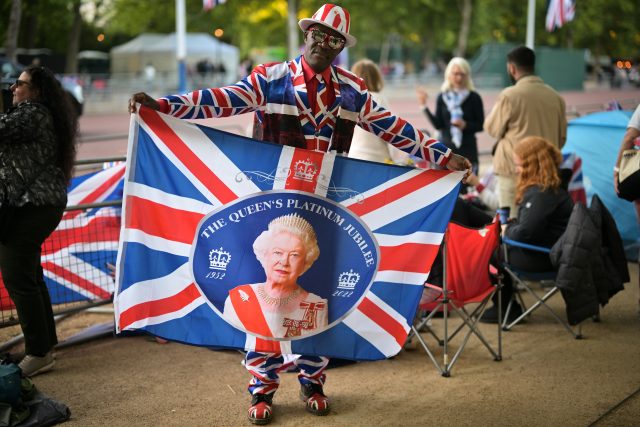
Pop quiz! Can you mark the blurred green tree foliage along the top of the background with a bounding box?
[0,0,640,59]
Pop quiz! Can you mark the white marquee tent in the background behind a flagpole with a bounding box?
[110,33,240,84]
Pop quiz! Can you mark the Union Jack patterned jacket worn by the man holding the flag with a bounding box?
[159,56,451,166]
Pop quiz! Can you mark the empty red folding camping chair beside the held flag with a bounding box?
[409,218,502,377]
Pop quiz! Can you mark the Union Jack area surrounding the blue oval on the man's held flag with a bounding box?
[114,107,462,360]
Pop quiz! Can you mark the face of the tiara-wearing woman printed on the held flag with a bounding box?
[264,231,307,286]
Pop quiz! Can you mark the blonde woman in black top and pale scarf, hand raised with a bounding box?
[417,57,484,174]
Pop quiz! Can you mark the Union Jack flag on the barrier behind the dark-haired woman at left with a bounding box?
[0,163,125,310]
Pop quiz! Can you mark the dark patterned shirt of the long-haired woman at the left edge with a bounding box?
[0,100,67,206]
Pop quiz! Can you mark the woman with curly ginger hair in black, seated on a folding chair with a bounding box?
[482,136,573,323]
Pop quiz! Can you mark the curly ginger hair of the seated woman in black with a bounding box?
[513,136,562,203]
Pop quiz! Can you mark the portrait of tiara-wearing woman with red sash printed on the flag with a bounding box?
[223,214,328,338]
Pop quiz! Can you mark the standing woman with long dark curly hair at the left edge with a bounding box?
[0,66,77,376]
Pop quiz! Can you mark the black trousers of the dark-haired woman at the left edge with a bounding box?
[0,204,64,356]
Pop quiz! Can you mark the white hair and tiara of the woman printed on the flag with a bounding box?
[253,214,320,273]
